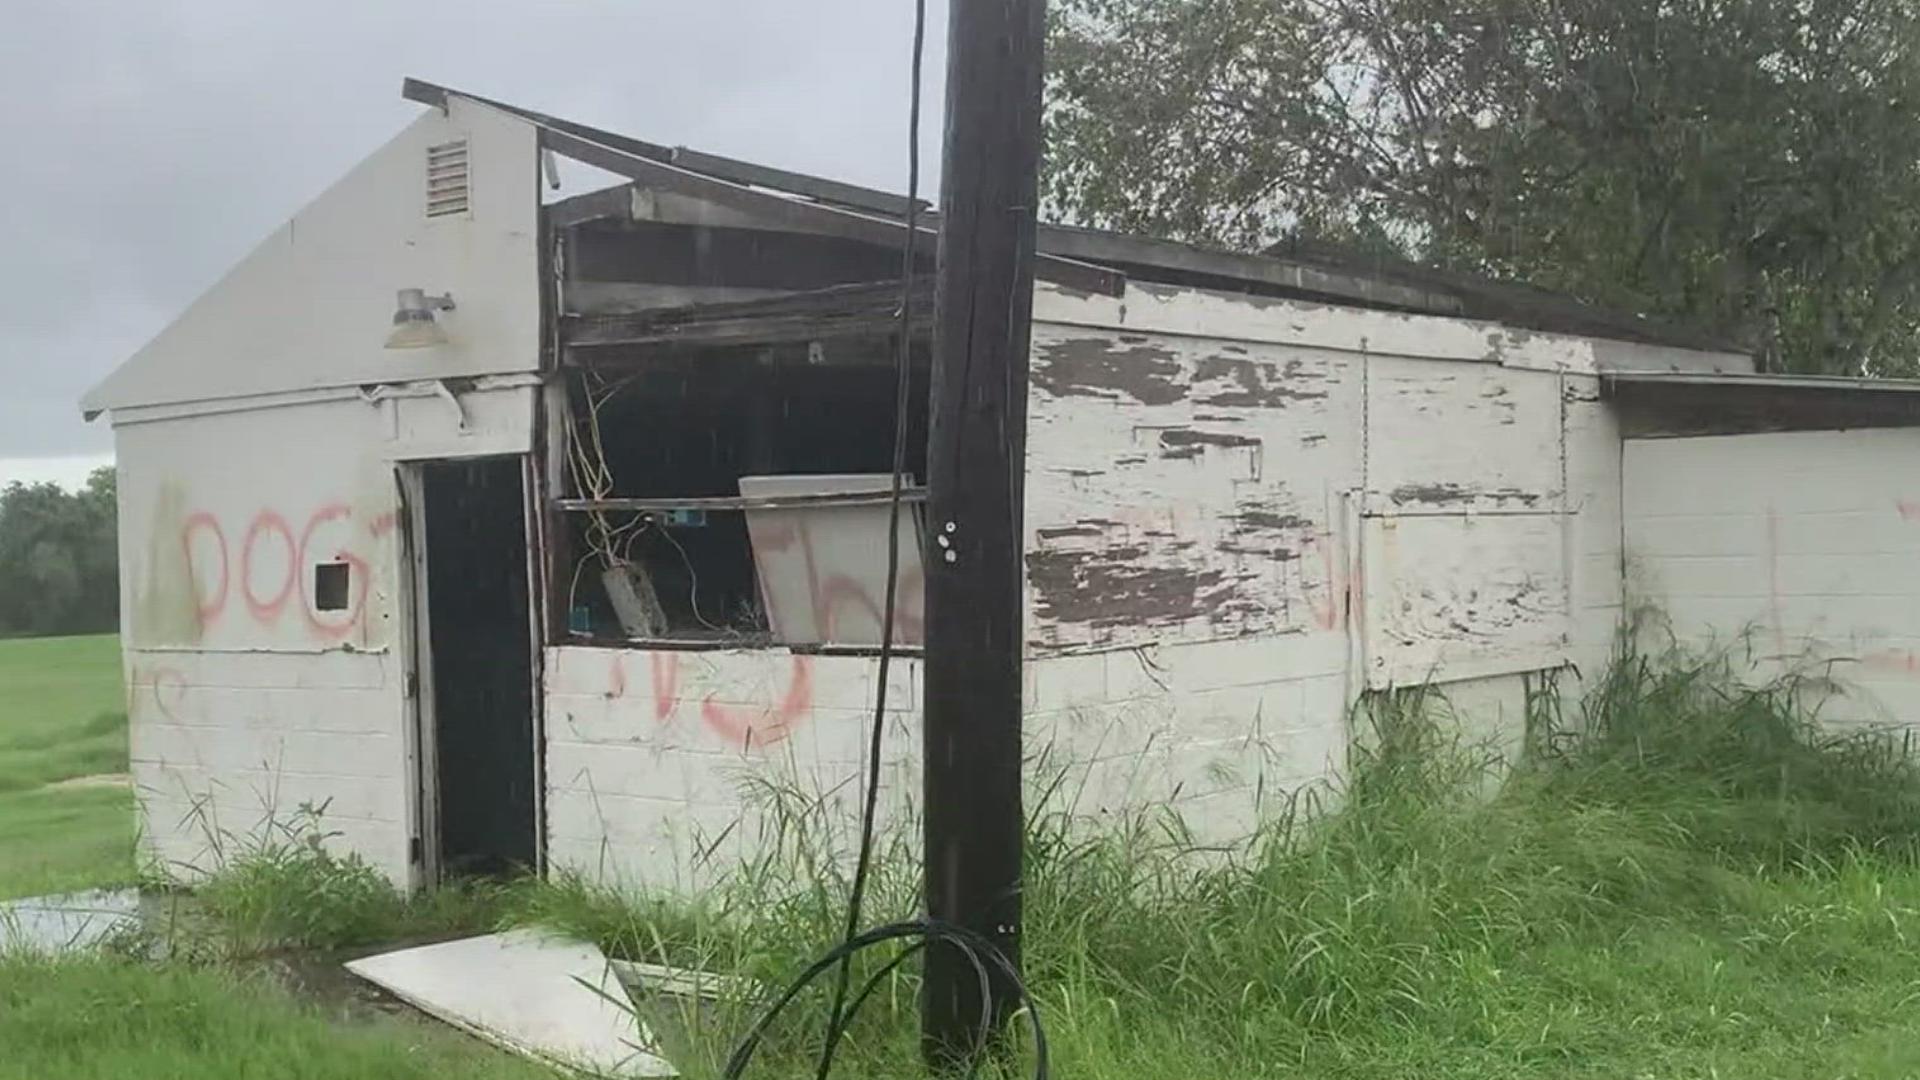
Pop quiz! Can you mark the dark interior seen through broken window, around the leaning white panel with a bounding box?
[564,338,927,640]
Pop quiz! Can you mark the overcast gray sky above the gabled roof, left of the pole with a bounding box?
[0,0,947,471]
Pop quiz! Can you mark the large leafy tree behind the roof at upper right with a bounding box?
[1046,0,1920,373]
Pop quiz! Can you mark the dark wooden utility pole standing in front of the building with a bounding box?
[922,0,1046,1065]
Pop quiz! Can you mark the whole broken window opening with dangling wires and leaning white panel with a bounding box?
[557,334,927,648]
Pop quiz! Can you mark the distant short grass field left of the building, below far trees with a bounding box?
[0,634,134,897]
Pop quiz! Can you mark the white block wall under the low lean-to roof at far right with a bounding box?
[1624,429,1920,724]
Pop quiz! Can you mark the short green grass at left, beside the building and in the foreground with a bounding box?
[0,634,553,1080]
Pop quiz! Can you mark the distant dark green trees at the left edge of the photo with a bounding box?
[0,469,119,636]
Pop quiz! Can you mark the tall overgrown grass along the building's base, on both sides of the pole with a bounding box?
[176,650,1920,1076]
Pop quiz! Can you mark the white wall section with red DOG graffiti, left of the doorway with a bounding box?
[115,374,532,884]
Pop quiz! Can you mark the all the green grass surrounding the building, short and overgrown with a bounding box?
[11,640,1920,1080]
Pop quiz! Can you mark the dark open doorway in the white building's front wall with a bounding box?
[420,457,540,878]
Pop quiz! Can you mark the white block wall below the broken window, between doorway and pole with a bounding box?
[545,646,920,892]
